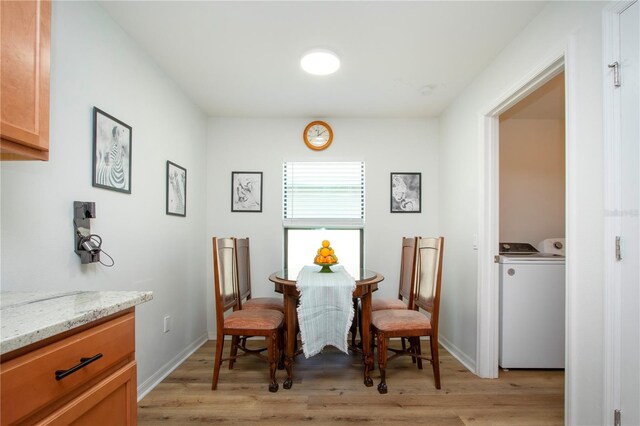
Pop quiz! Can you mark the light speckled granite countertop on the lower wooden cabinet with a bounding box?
[0,291,153,355]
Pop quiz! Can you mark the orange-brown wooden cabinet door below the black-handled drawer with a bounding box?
[38,361,138,426]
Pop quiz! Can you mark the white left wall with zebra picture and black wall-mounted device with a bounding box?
[0,2,207,396]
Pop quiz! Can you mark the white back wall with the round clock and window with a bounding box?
[206,118,446,334]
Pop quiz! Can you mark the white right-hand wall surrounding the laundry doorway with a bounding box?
[439,2,605,425]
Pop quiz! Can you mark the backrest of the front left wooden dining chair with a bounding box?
[213,237,238,327]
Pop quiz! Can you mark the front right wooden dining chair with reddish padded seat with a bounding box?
[371,237,444,393]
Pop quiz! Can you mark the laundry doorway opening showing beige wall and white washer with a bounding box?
[496,72,566,377]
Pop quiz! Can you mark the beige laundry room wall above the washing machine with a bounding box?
[499,118,565,247]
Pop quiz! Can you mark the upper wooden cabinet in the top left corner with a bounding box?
[0,0,51,160]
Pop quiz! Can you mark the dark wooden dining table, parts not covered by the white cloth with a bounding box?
[269,269,384,389]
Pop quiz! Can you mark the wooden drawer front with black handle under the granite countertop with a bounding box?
[0,313,135,424]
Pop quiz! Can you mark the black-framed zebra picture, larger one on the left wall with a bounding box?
[93,107,131,194]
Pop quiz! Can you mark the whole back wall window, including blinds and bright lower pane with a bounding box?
[282,162,364,275]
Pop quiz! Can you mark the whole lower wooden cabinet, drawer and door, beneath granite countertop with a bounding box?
[0,310,137,426]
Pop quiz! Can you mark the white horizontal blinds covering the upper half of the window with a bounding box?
[282,161,364,228]
